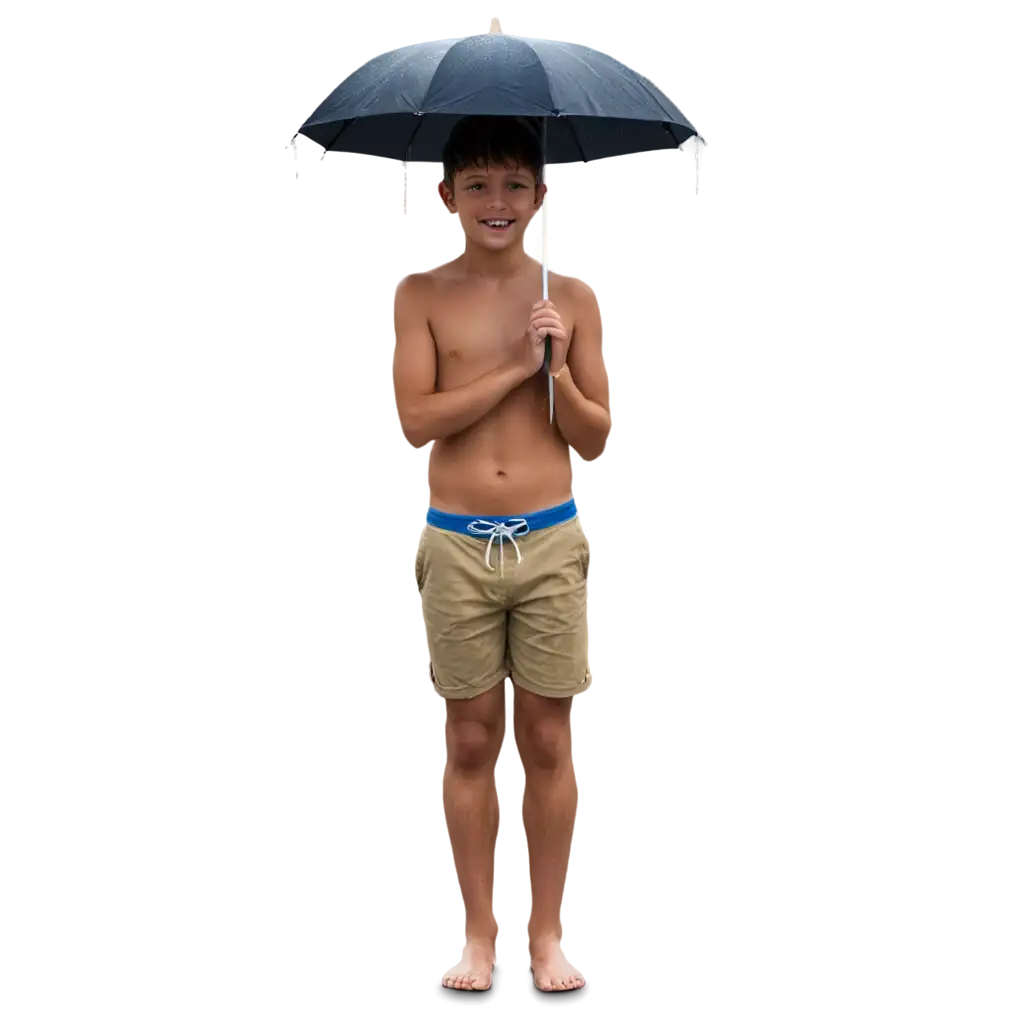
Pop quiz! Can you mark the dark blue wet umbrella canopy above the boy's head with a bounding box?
[292,33,698,167]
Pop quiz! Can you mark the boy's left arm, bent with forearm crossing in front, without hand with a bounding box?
[391,275,526,455]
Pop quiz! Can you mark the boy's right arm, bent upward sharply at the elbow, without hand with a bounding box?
[555,282,611,462]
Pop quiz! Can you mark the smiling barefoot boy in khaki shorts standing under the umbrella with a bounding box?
[392,118,611,994]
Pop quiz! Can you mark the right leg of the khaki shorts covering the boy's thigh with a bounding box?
[509,520,589,698]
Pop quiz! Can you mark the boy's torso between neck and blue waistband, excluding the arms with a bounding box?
[417,264,573,516]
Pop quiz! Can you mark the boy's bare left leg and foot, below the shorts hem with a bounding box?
[441,686,504,989]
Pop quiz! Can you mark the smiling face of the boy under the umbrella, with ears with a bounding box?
[440,165,546,250]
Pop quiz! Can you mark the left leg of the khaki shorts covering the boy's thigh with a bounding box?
[419,527,508,700]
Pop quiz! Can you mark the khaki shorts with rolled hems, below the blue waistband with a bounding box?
[415,517,591,700]
